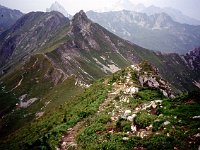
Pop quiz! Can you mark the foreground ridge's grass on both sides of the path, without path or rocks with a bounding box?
[1,64,200,150]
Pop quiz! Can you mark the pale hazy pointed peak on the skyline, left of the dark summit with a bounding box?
[46,1,72,18]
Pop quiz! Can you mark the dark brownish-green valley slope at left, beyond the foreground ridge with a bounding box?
[0,55,83,141]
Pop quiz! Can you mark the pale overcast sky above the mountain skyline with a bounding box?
[0,0,200,20]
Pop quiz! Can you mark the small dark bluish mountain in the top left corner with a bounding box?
[0,5,24,34]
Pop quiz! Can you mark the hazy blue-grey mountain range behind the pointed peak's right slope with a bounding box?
[87,10,200,54]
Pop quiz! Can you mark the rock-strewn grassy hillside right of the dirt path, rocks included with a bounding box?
[75,63,200,150]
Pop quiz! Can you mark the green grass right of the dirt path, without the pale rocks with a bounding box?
[77,67,200,150]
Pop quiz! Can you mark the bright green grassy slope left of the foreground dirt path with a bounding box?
[0,80,109,149]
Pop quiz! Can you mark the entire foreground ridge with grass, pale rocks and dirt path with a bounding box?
[1,62,200,150]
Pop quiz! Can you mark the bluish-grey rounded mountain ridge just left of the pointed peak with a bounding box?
[0,12,69,72]
